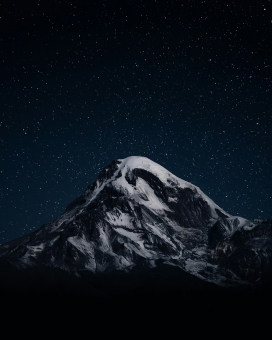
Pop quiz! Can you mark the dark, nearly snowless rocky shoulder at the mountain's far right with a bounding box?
[209,218,272,282]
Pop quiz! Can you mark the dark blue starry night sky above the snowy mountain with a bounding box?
[0,0,272,243]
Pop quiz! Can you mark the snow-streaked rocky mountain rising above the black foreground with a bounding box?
[0,156,272,286]
